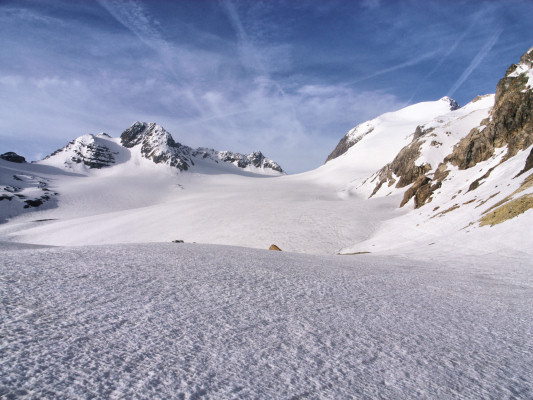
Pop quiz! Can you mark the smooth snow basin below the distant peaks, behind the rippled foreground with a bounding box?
[0,159,397,254]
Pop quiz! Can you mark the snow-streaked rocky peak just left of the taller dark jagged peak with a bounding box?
[44,133,118,169]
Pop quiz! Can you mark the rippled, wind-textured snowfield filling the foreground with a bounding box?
[0,243,533,399]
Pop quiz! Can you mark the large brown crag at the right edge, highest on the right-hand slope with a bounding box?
[446,48,533,169]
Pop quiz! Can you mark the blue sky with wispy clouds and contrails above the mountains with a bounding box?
[0,0,533,173]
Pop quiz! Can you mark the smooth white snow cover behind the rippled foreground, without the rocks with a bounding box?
[0,91,531,257]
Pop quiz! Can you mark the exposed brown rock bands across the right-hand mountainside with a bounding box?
[371,48,533,208]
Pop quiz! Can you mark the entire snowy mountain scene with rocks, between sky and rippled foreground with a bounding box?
[0,49,533,259]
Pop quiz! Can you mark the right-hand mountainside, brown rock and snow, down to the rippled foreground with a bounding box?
[336,49,533,259]
